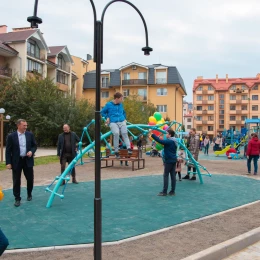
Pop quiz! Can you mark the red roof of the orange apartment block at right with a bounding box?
[193,77,260,91]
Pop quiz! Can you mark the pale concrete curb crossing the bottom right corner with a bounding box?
[182,227,260,260]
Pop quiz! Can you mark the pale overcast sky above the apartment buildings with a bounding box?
[0,0,260,101]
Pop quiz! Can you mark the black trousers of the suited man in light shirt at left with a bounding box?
[12,157,34,200]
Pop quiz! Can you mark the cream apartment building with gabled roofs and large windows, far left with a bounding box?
[0,25,77,94]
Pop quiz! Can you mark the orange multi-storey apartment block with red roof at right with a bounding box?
[193,74,260,137]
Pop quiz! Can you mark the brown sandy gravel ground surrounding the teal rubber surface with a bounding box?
[0,150,260,260]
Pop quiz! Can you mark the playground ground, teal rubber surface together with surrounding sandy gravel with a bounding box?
[0,147,260,260]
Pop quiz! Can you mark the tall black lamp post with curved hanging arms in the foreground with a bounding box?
[27,0,153,260]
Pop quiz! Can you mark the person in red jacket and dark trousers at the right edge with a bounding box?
[246,133,260,175]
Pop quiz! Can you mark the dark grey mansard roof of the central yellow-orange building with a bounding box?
[83,62,187,95]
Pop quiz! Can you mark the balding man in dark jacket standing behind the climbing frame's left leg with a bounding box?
[57,124,80,184]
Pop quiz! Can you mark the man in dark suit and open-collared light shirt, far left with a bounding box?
[5,119,37,207]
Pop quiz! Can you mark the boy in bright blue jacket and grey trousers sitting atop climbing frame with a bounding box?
[101,92,132,158]
